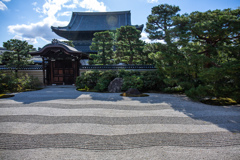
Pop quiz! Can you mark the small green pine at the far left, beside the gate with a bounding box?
[1,39,33,72]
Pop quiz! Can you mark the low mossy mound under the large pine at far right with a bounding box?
[201,98,237,106]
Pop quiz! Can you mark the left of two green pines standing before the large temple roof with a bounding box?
[89,31,114,65]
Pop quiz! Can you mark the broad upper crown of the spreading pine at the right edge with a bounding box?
[173,9,240,68]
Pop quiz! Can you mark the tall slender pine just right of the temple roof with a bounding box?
[145,4,184,86]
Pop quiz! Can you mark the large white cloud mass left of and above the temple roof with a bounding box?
[8,0,106,44]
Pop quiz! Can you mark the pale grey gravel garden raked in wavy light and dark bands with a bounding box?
[0,86,240,160]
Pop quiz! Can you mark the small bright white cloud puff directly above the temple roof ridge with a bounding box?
[79,0,107,12]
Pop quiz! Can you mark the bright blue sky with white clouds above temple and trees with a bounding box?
[0,0,240,48]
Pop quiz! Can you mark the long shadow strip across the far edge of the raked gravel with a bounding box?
[3,86,240,134]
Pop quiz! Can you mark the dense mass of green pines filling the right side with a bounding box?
[146,5,240,103]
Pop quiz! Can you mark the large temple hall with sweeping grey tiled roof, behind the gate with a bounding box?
[51,11,143,53]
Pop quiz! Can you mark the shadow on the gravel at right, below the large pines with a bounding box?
[131,94,240,134]
